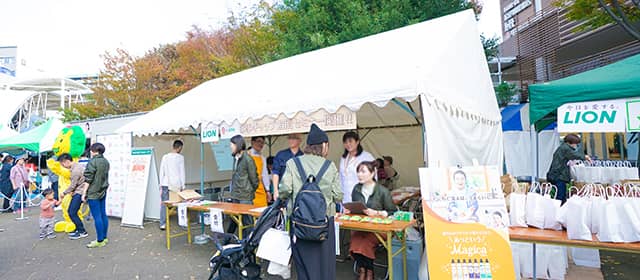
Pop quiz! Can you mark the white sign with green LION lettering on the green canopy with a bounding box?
[558,100,624,132]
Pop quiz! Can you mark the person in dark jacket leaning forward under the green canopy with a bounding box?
[547,134,591,203]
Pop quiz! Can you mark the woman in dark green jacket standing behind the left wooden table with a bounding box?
[227,135,259,236]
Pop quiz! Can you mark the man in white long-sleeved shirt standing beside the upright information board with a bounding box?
[160,140,185,230]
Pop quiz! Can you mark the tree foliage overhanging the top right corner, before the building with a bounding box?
[556,0,640,41]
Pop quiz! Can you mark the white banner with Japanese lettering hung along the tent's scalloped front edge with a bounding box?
[240,107,357,137]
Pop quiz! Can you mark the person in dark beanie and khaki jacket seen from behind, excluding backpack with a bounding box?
[280,124,343,280]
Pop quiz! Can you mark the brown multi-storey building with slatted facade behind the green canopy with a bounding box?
[500,0,640,101]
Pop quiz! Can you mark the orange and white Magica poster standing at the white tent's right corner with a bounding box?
[420,166,515,279]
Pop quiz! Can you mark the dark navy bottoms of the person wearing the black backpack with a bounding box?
[291,217,336,280]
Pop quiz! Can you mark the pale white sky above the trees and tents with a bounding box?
[0,0,501,76]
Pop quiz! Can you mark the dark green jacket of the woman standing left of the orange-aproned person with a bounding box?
[231,152,260,200]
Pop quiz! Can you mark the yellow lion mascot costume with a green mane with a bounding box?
[47,126,87,233]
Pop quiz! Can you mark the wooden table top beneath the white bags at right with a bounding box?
[509,227,640,253]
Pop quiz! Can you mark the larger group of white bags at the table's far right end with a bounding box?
[557,184,640,243]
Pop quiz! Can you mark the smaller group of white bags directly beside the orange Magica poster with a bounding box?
[509,183,562,230]
